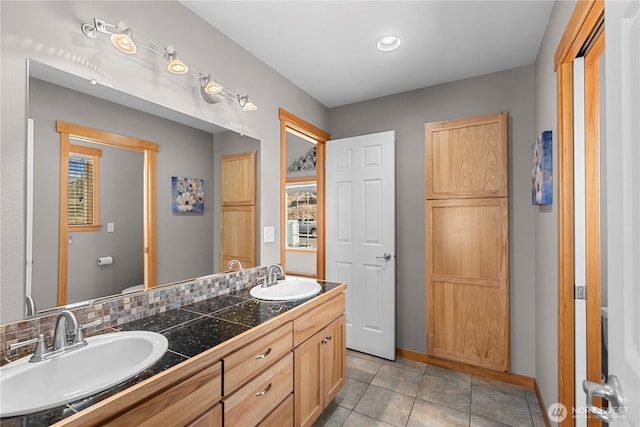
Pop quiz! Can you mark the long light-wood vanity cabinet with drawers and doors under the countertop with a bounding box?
[56,285,346,427]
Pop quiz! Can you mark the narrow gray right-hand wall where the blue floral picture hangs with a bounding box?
[534,1,575,412]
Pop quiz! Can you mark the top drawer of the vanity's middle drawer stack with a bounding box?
[223,322,293,396]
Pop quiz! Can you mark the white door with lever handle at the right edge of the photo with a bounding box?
[605,0,640,427]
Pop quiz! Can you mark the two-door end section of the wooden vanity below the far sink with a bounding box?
[293,294,346,426]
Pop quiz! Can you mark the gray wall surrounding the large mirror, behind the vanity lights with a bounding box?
[0,1,328,323]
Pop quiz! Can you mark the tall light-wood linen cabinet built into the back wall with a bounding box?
[425,112,509,372]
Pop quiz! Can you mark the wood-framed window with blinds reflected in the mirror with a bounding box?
[67,144,102,231]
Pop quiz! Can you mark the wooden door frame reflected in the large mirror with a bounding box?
[56,121,159,306]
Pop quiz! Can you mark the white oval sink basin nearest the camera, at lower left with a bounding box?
[0,331,169,417]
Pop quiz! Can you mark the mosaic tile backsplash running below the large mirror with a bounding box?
[0,267,266,365]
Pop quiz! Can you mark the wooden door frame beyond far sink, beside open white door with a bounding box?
[278,108,331,280]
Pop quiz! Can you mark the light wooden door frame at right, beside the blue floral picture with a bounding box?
[554,0,604,426]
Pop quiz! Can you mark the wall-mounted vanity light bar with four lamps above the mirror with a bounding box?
[81,18,258,112]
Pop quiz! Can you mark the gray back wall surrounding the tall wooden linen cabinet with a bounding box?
[329,66,536,376]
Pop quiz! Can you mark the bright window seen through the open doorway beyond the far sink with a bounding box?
[286,181,318,251]
